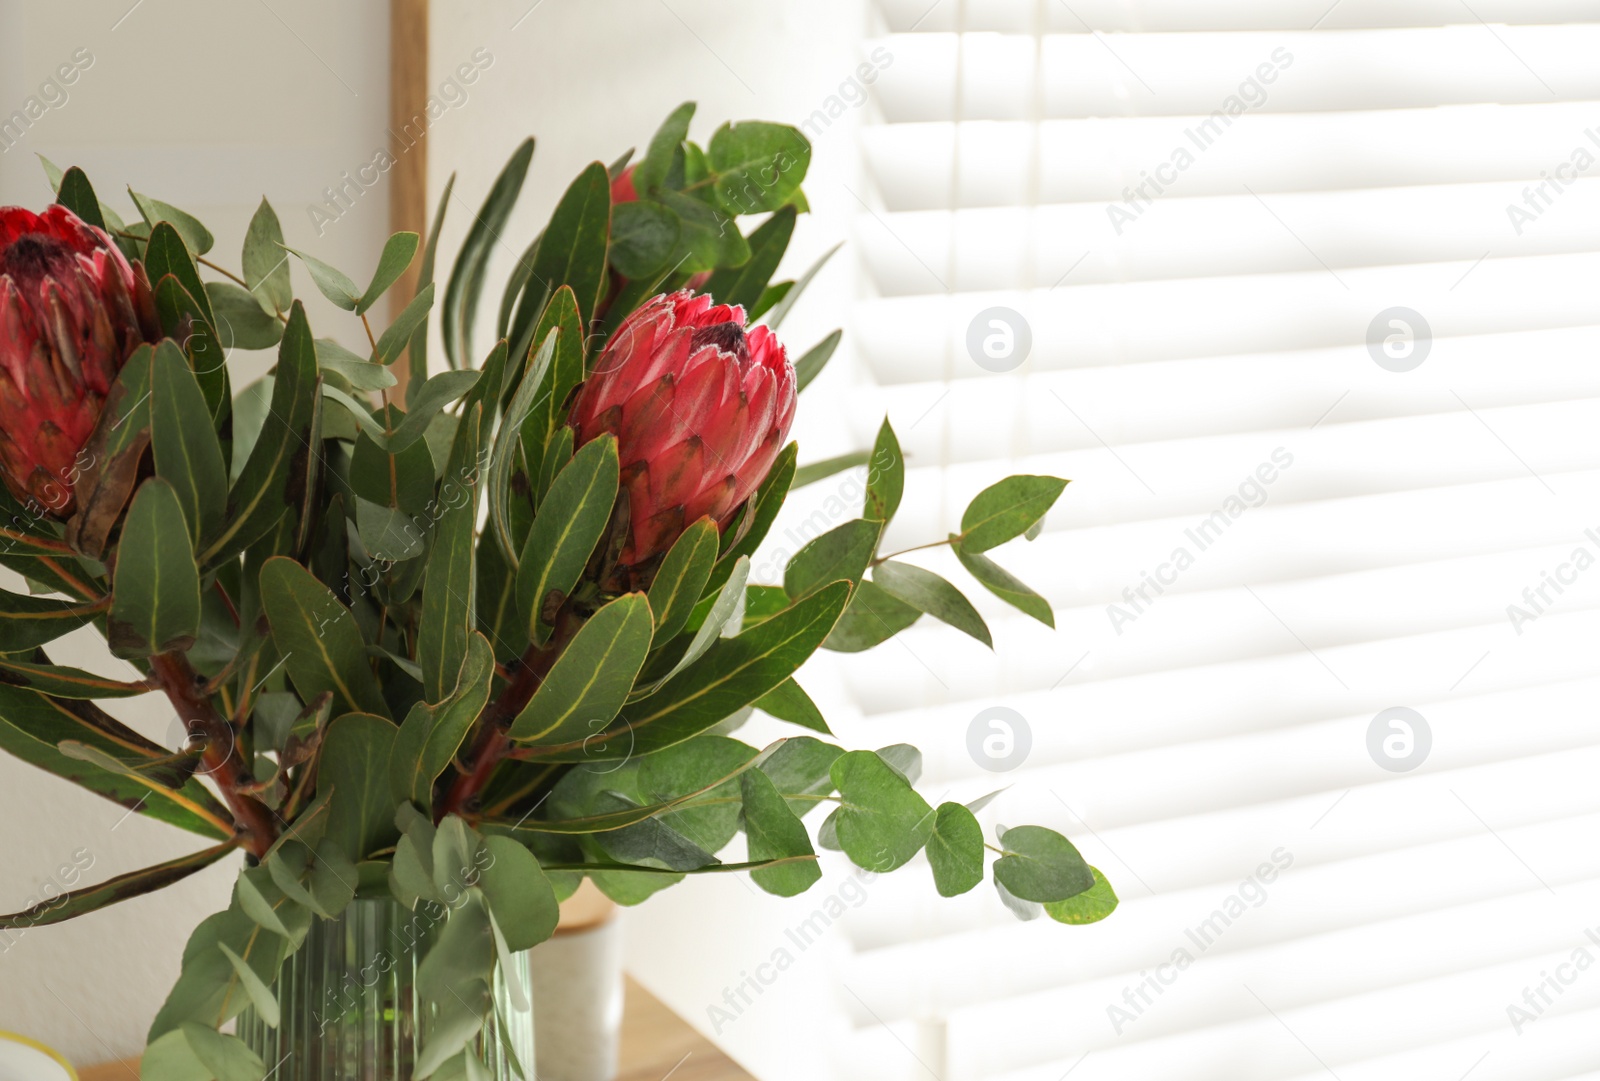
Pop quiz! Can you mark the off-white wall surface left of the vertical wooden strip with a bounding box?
[0,0,389,1063]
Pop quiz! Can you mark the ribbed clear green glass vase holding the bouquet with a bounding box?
[237,899,534,1081]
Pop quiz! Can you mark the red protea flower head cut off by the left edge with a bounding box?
[0,205,160,518]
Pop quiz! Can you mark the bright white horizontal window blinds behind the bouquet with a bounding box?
[830,0,1600,1081]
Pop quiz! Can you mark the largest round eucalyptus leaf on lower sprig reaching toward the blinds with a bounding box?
[832,750,934,873]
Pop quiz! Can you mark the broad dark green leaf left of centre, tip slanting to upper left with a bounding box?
[261,556,389,716]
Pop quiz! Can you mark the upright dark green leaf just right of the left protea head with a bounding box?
[152,339,227,547]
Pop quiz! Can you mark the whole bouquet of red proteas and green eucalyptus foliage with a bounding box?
[0,104,1115,1081]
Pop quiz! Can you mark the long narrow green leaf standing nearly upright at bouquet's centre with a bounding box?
[416,406,483,702]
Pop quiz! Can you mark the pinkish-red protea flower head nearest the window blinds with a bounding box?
[571,289,795,566]
